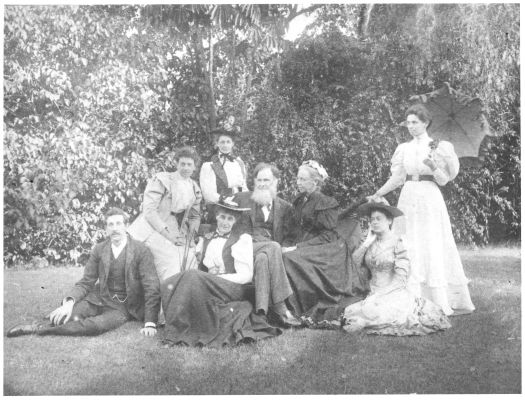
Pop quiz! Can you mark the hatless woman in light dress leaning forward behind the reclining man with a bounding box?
[128,147,202,283]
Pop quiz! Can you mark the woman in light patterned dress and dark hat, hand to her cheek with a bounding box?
[343,203,450,336]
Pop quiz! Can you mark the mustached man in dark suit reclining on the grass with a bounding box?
[7,208,160,337]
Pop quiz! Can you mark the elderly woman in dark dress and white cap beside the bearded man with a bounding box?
[283,160,364,327]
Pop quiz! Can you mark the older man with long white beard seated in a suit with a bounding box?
[233,163,301,327]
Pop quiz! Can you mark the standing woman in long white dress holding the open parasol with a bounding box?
[368,104,475,315]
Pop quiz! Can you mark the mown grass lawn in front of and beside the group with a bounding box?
[4,248,521,395]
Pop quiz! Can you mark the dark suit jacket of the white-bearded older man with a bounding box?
[233,192,293,245]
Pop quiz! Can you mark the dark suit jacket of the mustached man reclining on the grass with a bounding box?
[67,235,160,323]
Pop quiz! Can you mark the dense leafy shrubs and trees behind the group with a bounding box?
[3,4,521,267]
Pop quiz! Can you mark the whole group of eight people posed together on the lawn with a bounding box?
[7,105,474,347]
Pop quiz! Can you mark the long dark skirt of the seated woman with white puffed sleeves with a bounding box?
[161,270,281,347]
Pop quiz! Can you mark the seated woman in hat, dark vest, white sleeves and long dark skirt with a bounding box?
[162,202,281,347]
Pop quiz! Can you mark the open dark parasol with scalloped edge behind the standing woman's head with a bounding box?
[409,82,492,158]
